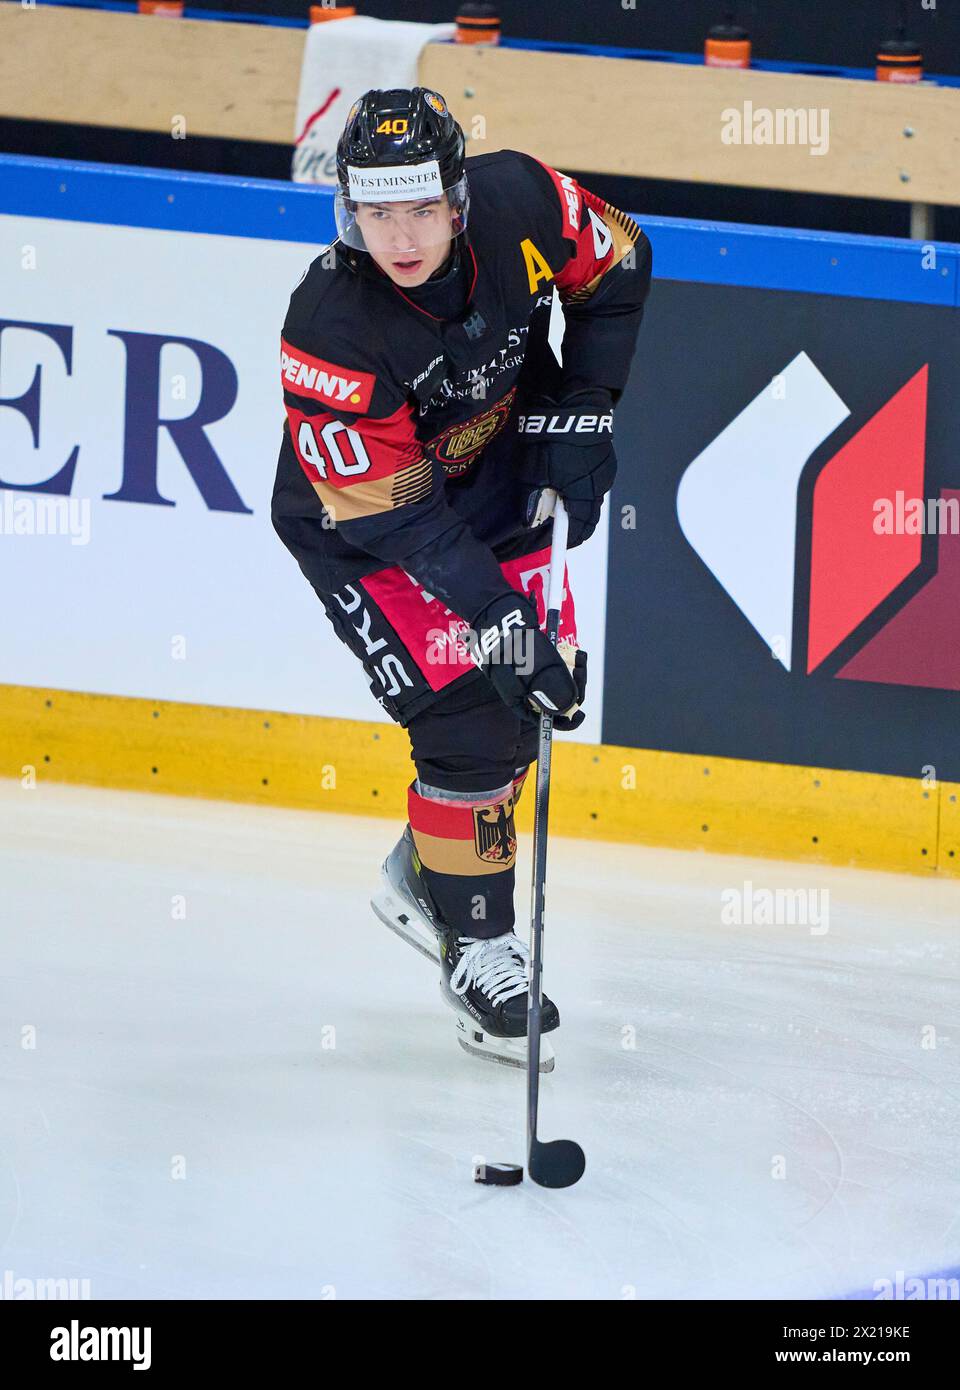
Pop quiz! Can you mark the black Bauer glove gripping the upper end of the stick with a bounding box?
[517,386,617,546]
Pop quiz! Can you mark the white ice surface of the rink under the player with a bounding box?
[0,781,960,1300]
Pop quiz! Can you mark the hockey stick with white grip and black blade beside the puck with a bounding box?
[527,496,586,1187]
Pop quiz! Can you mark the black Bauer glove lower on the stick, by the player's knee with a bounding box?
[471,594,586,730]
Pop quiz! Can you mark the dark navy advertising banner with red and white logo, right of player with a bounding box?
[603,282,960,780]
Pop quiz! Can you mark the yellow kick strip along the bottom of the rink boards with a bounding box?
[0,685,960,877]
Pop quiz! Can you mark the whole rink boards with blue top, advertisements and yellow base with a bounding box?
[0,156,960,874]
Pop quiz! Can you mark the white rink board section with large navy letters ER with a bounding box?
[0,215,607,742]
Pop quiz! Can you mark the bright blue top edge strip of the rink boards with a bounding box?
[0,154,960,307]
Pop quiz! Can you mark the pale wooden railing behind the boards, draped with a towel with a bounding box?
[0,0,960,235]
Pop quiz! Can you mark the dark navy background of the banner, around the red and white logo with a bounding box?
[602,281,960,781]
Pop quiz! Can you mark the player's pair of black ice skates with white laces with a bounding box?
[371,826,560,1072]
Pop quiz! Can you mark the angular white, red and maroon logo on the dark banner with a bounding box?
[677,352,960,691]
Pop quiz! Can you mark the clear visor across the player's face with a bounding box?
[333,174,470,256]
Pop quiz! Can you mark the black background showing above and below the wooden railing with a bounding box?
[0,0,960,240]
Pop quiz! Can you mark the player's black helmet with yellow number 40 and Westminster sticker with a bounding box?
[335,88,470,250]
